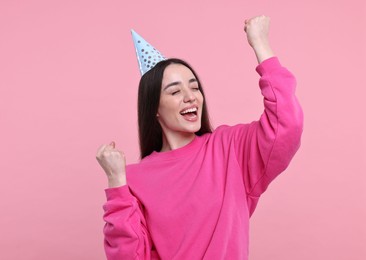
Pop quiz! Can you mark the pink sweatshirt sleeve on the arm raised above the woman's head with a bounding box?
[234,57,303,214]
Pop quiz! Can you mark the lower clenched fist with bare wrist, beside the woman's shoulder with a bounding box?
[96,142,126,188]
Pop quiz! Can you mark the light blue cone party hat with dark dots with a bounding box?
[131,30,165,76]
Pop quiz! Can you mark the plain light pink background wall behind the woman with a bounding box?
[0,0,366,260]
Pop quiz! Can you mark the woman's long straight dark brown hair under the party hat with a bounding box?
[137,58,212,159]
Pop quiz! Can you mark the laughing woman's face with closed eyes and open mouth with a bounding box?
[157,64,203,139]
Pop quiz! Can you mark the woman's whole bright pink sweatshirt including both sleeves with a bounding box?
[104,57,303,260]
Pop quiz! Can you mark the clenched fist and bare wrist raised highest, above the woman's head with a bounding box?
[244,15,274,63]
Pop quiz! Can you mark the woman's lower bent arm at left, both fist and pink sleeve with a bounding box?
[96,142,153,260]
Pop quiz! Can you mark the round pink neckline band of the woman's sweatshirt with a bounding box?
[148,136,201,160]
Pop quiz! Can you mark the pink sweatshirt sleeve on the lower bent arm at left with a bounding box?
[103,185,152,260]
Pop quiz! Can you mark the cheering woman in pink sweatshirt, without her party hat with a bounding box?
[97,16,303,259]
